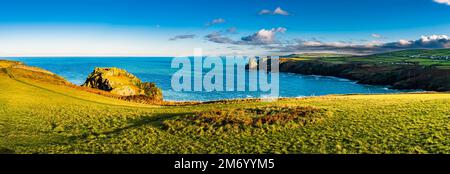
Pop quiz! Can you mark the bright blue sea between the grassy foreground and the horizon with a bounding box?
[13,57,412,101]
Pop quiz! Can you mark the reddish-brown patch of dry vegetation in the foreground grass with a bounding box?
[163,106,331,130]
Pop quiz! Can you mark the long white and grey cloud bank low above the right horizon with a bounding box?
[205,27,450,54]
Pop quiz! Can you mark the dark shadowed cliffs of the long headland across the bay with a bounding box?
[280,59,450,91]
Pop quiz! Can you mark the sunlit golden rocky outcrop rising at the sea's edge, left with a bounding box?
[82,68,163,101]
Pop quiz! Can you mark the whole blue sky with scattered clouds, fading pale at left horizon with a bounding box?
[0,0,450,56]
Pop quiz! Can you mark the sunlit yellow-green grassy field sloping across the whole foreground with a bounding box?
[0,59,450,153]
